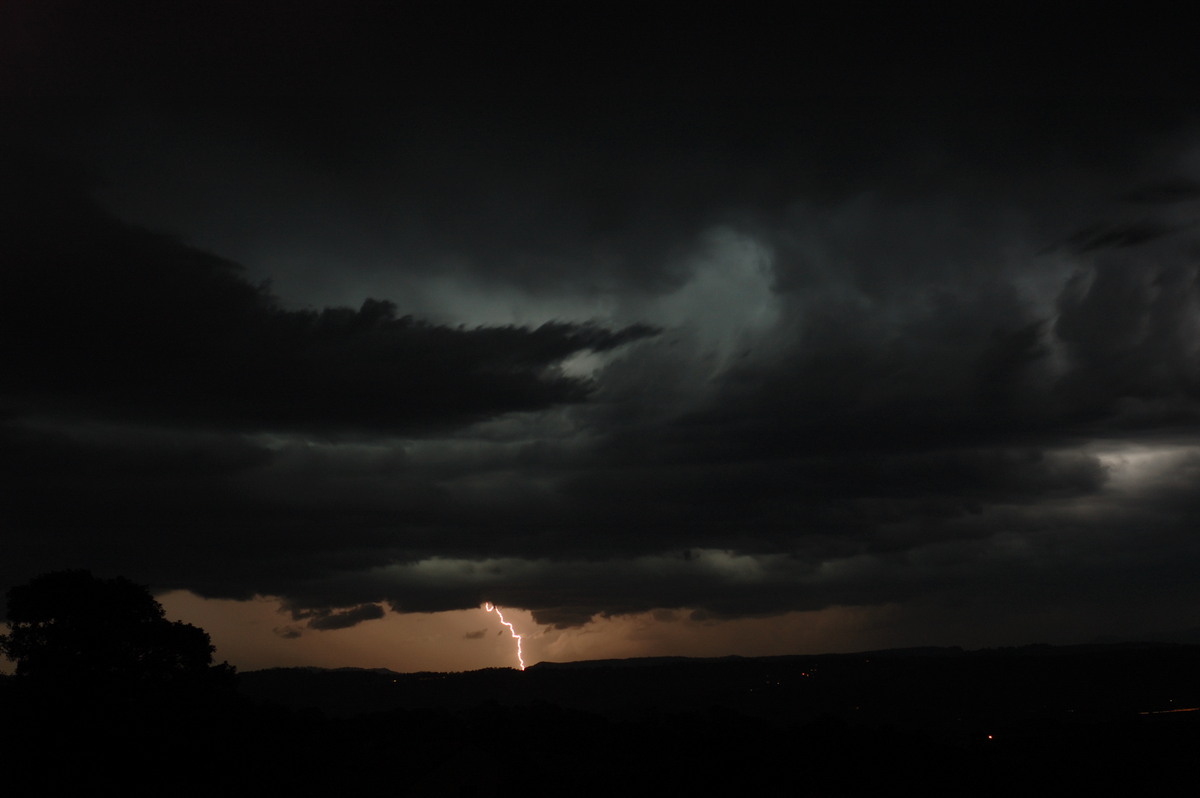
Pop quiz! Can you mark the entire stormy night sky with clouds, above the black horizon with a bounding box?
[0,2,1200,670]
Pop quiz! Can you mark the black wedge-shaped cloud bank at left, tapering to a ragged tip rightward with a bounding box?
[0,151,654,433]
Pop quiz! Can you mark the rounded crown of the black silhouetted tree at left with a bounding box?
[0,571,223,685]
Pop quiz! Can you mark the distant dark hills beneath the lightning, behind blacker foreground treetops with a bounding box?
[239,643,1200,731]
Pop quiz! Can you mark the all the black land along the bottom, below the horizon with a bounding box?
[0,644,1200,797]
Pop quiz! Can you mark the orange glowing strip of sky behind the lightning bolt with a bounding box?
[157,590,1070,673]
